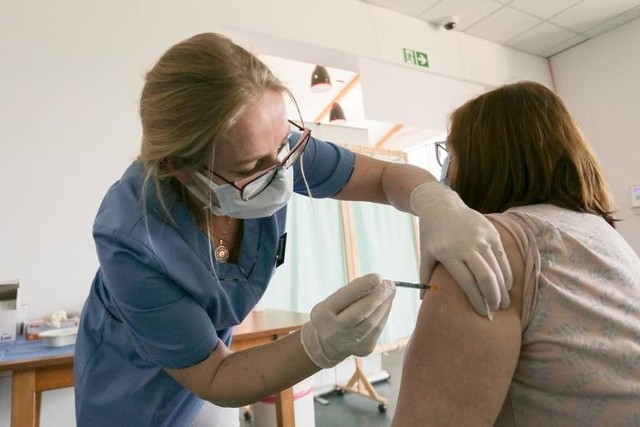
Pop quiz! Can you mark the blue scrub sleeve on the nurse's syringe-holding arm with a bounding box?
[94,228,218,369]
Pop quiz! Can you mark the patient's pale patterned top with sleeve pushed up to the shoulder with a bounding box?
[489,205,640,427]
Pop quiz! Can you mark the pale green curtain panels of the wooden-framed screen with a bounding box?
[262,152,420,346]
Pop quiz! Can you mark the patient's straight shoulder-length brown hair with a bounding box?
[448,82,615,226]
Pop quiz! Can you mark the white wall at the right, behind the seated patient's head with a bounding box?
[551,19,640,254]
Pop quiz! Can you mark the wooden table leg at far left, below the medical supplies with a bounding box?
[11,370,40,427]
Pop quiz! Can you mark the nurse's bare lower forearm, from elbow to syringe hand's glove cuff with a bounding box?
[200,331,320,407]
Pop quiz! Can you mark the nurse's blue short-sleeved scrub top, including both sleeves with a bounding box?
[74,134,354,427]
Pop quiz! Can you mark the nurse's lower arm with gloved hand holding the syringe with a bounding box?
[165,274,395,407]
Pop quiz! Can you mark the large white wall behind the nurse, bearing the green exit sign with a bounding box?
[0,0,550,427]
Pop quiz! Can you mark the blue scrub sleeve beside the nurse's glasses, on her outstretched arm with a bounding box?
[291,135,355,199]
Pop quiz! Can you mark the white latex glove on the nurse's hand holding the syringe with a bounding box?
[300,274,396,368]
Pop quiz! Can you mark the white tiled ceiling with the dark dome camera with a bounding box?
[362,0,640,58]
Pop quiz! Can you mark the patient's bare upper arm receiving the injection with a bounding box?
[394,221,524,427]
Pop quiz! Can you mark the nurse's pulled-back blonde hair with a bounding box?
[138,33,291,216]
